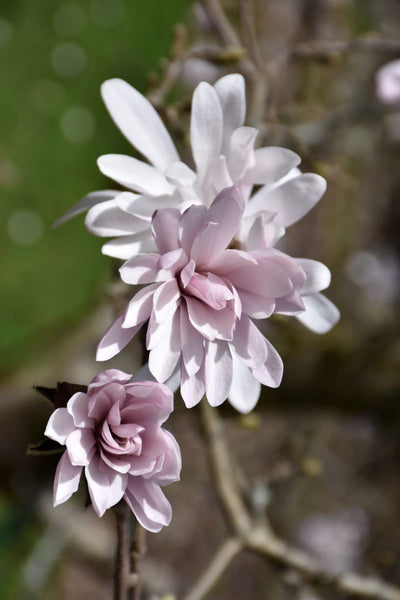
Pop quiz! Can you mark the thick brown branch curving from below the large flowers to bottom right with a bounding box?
[195,400,400,600]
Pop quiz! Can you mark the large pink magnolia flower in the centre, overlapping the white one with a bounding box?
[97,186,330,412]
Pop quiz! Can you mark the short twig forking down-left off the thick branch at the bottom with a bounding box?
[183,538,243,600]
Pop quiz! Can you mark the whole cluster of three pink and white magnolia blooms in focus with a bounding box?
[47,74,339,531]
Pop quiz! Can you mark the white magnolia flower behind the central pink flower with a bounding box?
[58,74,339,333]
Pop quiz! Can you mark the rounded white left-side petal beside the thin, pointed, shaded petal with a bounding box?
[85,196,148,237]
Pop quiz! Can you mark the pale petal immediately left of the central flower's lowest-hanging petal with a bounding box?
[205,340,232,406]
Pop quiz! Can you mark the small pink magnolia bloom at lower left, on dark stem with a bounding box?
[45,369,181,531]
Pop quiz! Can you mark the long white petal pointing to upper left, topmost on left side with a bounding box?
[101,79,179,171]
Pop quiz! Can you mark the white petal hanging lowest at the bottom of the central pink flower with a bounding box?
[228,352,261,414]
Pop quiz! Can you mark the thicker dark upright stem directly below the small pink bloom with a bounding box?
[114,501,131,600]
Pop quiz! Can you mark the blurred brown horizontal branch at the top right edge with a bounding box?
[292,37,400,59]
